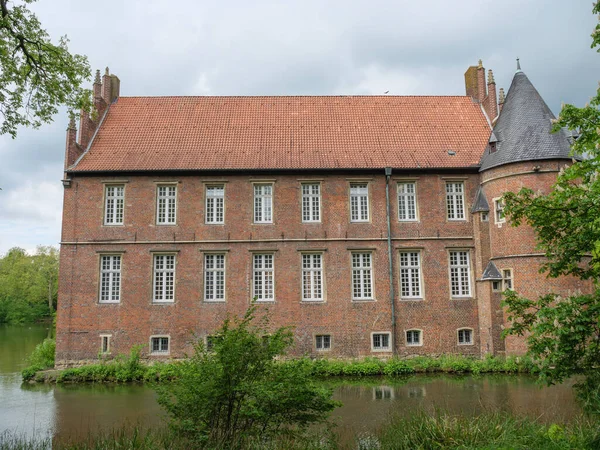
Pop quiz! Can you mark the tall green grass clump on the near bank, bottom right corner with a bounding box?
[370,412,600,450]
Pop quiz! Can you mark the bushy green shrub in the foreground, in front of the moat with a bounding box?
[155,306,338,449]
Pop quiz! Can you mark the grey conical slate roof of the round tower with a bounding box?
[480,66,571,171]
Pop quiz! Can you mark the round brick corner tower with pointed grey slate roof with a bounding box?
[473,60,589,354]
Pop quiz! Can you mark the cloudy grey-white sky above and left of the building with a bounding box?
[0,0,600,254]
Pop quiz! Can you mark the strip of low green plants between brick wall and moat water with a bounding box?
[22,339,537,383]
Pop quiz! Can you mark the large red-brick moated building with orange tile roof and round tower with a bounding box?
[56,63,581,366]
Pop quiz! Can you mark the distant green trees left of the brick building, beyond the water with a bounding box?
[0,246,58,324]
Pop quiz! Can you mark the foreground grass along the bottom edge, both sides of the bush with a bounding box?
[0,412,600,450]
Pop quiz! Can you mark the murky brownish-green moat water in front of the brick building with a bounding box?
[0,326,581,439]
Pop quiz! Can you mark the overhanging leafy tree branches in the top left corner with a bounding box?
[0,0,91,138]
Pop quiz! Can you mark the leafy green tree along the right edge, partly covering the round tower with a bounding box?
[504,2,600,411]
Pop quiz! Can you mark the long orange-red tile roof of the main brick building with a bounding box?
[70,96,490,172]
